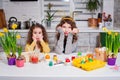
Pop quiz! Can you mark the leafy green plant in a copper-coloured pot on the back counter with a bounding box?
[86,0,101,28]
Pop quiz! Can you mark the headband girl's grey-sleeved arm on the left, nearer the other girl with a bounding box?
[55,29,64,54]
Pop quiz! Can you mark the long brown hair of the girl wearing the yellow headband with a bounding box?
[56,16,78,43]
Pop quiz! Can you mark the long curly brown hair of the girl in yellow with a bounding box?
[27,23,49,52]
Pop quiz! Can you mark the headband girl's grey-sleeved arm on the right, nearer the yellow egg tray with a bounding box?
[65,33,77,54]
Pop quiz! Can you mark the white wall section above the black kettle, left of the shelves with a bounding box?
[3,0,41,22]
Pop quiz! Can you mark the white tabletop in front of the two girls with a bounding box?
[0,53,120,79]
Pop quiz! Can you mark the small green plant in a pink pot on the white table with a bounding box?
[16,46,25,67]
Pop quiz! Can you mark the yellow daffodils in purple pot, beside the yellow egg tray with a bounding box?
[103,28,120,65]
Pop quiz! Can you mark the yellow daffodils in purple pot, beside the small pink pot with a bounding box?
[0,24,20,65]
